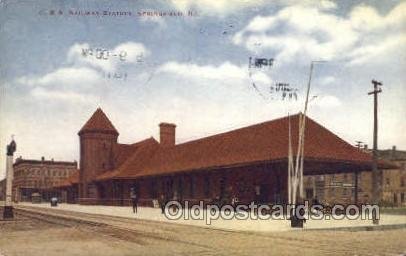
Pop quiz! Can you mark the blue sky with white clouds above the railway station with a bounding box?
[0,0,406,178]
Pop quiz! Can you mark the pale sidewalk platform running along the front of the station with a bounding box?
[15,203,406,232]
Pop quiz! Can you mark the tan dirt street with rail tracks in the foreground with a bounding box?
[0,210,406,256]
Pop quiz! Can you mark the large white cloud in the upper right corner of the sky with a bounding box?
[233,3,406,64]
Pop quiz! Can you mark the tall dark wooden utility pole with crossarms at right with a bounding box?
[368,80,382,225]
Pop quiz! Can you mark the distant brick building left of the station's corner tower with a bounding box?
[13,157,77,201]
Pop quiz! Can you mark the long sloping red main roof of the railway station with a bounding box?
[98,115,382,180]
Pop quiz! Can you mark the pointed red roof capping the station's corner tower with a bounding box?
[78,108,118,135]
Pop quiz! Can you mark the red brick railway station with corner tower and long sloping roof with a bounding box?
[57,108,385,206]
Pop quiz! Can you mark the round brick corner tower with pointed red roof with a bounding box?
[78,108,118,204]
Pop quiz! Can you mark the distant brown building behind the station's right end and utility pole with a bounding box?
[304,146,406,206]
